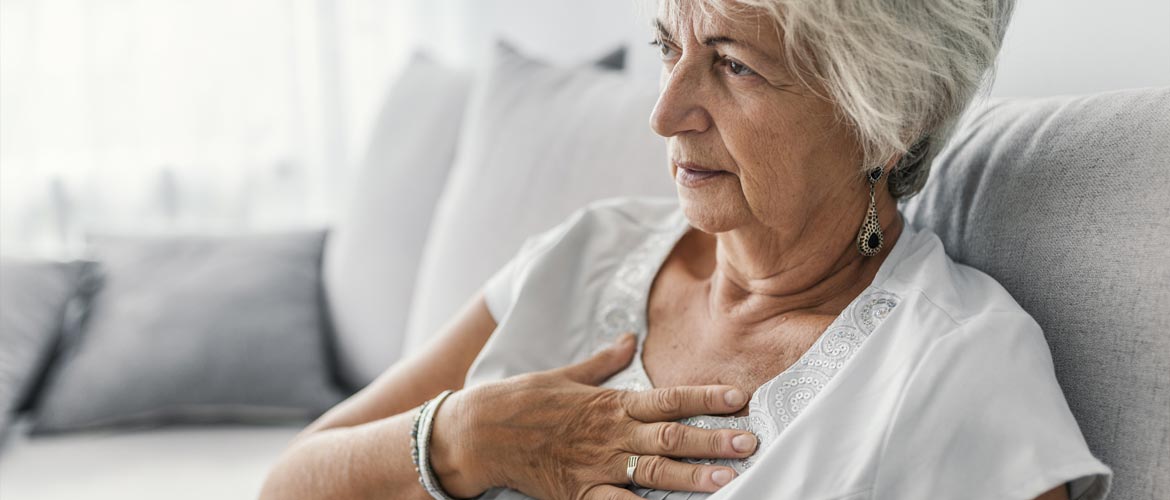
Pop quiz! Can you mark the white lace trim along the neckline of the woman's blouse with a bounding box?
[591,212,900,473]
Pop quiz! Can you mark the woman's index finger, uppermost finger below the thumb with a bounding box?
[622,385,748,422]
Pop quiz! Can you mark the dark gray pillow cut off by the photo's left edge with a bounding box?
[0,259,80,440]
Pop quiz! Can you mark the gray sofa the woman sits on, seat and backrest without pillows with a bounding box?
[0,72,1170,500]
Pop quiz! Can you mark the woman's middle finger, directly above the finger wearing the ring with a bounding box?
[626,422,757,458]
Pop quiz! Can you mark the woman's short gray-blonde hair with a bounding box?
[659,0,1014,199]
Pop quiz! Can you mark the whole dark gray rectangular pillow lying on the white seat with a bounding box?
[30,231,342,434]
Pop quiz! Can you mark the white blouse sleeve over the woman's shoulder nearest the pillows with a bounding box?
[466,197,684,384]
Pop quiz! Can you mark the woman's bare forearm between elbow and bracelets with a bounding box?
[260,410,431,500]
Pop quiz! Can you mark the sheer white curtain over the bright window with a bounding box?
[0,0,426,258]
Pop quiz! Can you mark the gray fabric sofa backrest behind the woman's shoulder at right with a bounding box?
[904,88,1170,499]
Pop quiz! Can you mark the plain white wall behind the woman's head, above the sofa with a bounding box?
[413,0,1170,96]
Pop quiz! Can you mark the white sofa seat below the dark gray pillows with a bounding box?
[0,419,305,500]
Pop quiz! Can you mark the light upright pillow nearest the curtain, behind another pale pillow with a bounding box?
[324,53,470,388]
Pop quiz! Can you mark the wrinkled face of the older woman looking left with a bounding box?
[651,2,868,240]
